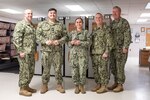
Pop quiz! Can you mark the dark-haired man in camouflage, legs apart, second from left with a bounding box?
[36,8,66,94]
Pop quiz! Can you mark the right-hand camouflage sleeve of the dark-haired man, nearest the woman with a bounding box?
[59,25,68,44]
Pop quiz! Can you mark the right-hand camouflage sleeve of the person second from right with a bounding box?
[105,27,114,53]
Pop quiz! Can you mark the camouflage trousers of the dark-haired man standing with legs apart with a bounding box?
[42,51,63,84]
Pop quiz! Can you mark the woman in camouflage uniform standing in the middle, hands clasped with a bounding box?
[68,17,90,94]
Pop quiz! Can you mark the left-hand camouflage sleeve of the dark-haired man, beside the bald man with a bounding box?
[36,23,47,44]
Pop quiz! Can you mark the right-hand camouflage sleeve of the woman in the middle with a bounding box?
[80,30,91,47]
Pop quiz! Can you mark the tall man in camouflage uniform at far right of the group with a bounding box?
[108,6,131,92]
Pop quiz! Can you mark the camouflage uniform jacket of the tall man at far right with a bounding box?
[111,18,131,49]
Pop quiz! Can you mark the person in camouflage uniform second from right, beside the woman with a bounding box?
[90,13,112,93]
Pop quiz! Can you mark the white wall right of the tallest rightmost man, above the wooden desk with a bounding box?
[129,24,150,57]
